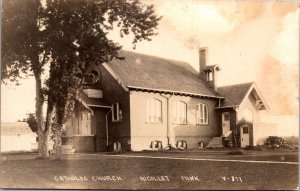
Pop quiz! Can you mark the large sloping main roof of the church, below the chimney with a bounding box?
[104,51,221,98]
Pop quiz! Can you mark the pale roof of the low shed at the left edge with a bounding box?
[1,122,35,135]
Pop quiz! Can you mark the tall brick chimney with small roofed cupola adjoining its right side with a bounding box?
[199,47,220,90]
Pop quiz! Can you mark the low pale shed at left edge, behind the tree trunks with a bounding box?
[1,122,37,152]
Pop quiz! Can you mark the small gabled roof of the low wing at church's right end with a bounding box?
[218,82,268,109]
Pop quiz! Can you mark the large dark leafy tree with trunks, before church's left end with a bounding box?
[1,0,160,158]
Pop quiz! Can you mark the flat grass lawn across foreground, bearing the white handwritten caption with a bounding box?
[0,152,298,190]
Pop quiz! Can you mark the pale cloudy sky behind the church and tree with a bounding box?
[1,0,299,136]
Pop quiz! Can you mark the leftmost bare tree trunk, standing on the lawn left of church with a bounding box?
[35,72,49,158]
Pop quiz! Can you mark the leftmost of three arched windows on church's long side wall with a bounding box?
[147,99,162,123]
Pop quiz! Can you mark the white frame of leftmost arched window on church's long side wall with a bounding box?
[146,98,163,123]
